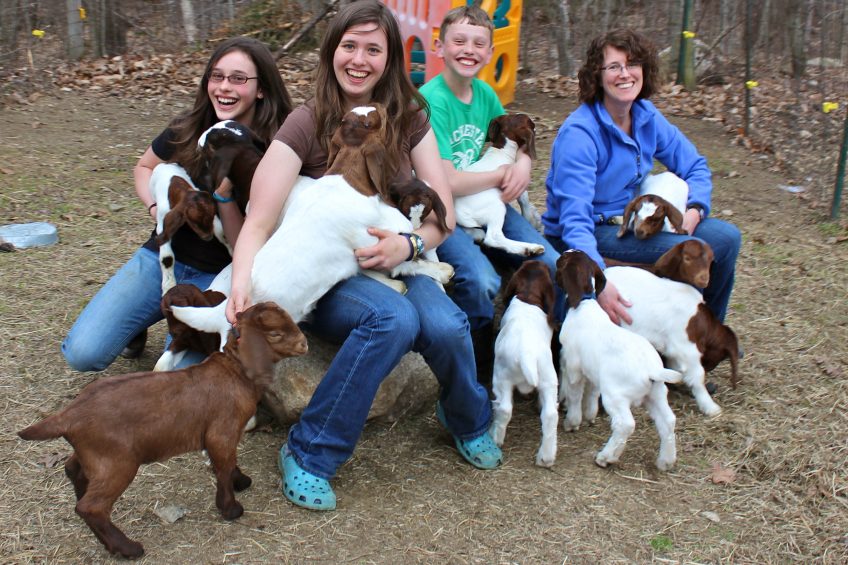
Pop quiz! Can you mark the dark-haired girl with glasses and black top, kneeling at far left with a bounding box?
[62,37,292,371]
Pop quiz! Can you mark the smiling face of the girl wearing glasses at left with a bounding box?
[206,51,264,127]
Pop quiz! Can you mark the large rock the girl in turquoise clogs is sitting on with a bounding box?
[263,336,438,424]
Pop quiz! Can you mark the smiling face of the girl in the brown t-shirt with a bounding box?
[333,23,389,109]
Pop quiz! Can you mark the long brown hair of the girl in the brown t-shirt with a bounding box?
[315,0,429,178]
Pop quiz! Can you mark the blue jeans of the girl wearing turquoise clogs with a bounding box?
[288,275,492,479]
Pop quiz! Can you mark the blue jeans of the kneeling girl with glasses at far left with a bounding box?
[62,247,215,371]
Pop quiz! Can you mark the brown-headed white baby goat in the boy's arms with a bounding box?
[454,114,545,257]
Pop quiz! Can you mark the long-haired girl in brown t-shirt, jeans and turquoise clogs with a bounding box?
[227,0,501,510]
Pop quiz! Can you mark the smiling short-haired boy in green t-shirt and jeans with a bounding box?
[421,6,562,384]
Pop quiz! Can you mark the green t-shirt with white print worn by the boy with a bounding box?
[420,75,506,171]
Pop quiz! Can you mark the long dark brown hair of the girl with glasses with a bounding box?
[168,37,292,179]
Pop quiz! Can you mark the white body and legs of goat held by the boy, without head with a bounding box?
[454,138,545,257]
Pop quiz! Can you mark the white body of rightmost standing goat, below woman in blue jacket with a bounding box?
[604,267,721,416]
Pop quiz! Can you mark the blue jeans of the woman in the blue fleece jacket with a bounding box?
[551,218,742,322]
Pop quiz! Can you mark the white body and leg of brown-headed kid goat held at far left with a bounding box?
[150,163,227,295]
